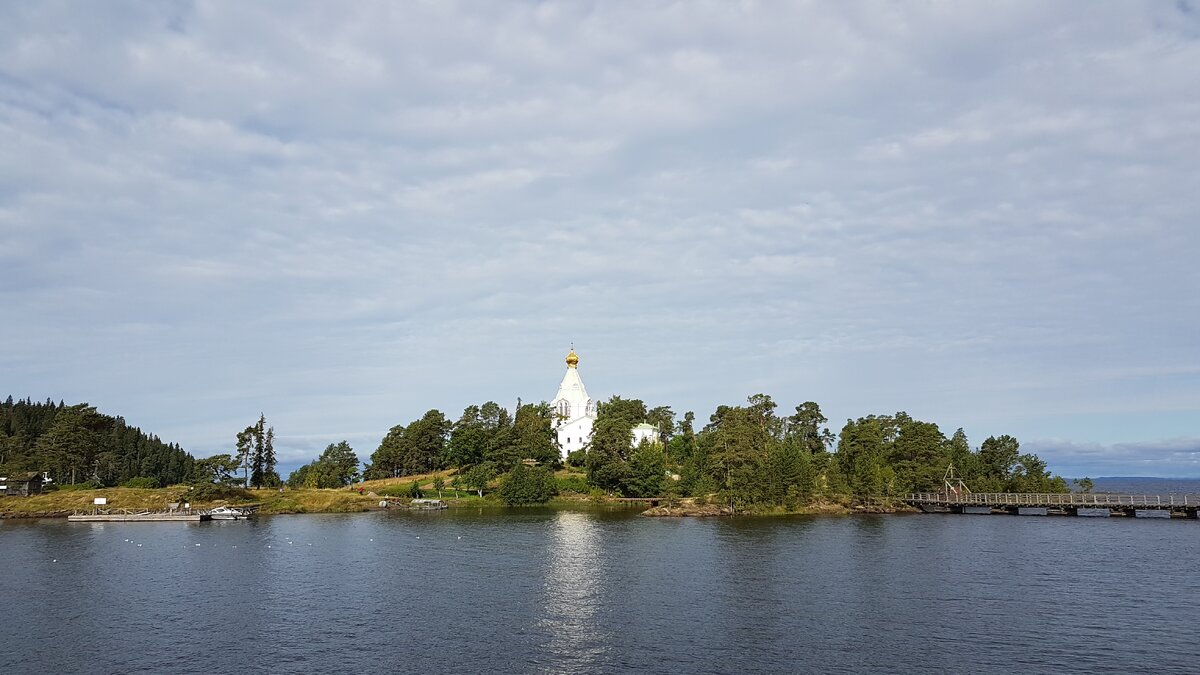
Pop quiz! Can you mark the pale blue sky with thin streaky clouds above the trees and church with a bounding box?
[0,0,1200,477]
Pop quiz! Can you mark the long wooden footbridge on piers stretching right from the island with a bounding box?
[904,490,1200,518]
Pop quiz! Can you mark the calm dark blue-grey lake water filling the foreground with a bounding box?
[0,510,1200,673]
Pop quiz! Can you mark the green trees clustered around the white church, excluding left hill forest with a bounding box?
[365,394,1068,508]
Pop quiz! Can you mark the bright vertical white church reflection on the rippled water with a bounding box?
[541,512,607,671]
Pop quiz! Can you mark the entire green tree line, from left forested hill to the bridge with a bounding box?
[0,394,1067,508]
